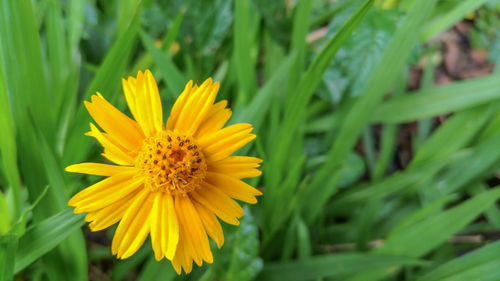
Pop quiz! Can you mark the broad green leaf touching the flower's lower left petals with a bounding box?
[14,210,85,273]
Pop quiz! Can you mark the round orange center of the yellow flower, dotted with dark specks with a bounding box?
[135,131,207,195]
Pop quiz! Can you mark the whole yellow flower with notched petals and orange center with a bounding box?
[66,70,262,274]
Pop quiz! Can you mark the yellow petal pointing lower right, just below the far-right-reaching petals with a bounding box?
[190,180,243,225]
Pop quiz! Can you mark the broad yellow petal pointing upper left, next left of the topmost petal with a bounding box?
[84,95,144,151]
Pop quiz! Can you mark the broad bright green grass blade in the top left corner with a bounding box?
[0,0,55,140]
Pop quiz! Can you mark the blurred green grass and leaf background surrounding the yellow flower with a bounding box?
[0,0,500,281]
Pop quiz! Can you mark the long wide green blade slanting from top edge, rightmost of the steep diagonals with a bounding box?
[301,0,436,222]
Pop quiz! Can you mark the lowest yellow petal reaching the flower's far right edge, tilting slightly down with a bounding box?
[205,172,262,204]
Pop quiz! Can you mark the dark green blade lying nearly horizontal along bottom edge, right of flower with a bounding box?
[258,253,425,281]
